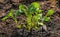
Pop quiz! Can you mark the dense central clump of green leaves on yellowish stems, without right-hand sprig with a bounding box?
[16,2,43,30]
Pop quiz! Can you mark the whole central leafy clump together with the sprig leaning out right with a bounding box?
[16,2,54,30]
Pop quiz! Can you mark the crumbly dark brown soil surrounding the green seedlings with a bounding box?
[0,0,60,37]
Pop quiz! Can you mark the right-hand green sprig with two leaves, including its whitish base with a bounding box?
[38,9,54,25]
